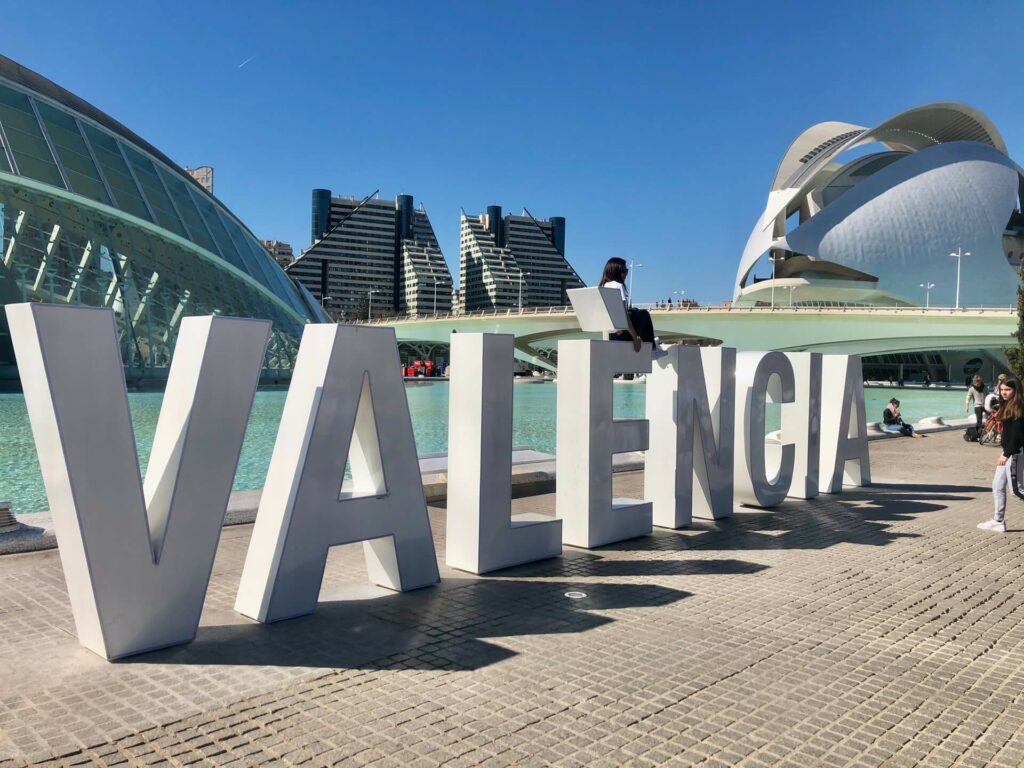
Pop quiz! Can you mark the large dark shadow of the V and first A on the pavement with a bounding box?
[120,579,690,671]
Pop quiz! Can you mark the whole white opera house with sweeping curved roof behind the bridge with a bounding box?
[733,102,1024,381]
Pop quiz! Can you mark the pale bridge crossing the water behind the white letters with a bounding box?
[374,307,1017,370]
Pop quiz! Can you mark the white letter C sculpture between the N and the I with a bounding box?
[734,352,797,508]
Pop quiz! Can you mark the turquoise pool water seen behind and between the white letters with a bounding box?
[0,381,964,514]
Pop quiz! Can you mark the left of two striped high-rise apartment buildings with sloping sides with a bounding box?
[288,189,452,319]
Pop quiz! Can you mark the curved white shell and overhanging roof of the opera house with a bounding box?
[735,102,1019,305]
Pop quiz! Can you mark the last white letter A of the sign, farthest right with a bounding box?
[818,354,871,494]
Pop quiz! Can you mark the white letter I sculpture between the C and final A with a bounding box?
[782,352,821,499]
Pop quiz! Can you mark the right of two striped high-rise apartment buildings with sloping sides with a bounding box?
[459,206,584,311]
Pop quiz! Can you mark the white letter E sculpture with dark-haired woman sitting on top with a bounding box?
[555,341,651,549]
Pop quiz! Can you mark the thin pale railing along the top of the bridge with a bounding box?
[354,303,1017,325]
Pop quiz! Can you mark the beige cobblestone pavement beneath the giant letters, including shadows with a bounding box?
[0,433,1024,766]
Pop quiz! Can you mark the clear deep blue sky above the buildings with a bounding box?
[0,0,1024,303]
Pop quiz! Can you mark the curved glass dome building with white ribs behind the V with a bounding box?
[0,56,328,379]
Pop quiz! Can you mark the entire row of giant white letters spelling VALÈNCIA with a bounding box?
[7,303,869,658]
